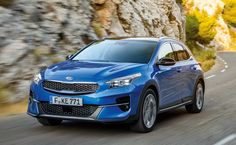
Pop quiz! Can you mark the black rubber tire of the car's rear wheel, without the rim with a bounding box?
[185,82,204,113]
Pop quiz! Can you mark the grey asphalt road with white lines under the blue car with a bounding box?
[0,52,236,145]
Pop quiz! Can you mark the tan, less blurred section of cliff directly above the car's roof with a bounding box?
[92,0,184,40]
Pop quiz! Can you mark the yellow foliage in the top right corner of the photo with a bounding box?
[223,0,236,27]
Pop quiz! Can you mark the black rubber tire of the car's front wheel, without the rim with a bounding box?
[130,89,158,133]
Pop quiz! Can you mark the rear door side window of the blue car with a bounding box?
[172,43,189,61]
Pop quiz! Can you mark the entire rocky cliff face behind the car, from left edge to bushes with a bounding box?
[0,0,185,103]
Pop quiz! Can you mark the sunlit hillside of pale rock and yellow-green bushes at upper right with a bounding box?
[182,0,236,50]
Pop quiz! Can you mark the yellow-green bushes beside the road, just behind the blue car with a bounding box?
[183,5,218,71]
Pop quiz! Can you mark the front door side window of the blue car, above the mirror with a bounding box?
[158,43,175,60]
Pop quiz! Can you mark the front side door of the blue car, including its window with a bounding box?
[155,42,183,109]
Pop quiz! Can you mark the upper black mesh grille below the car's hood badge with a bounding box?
[43,81,98,94]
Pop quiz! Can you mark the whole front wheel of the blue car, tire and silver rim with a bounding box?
[131,89,158,133]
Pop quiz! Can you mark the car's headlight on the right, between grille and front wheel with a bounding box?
[106,73,141,88]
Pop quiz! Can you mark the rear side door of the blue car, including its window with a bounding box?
[171,43,192,102]
